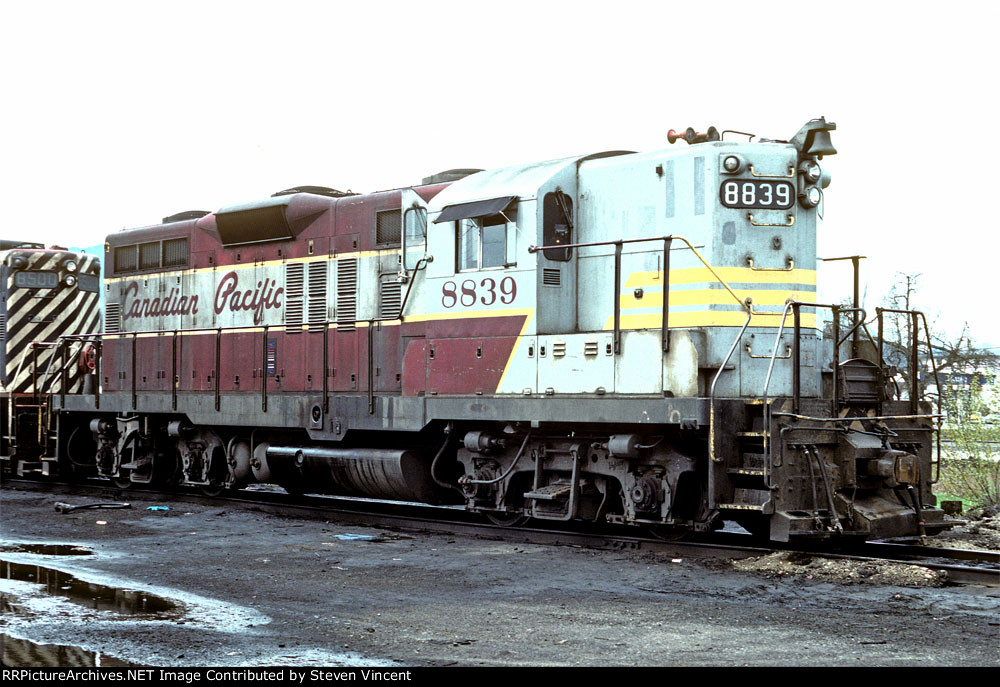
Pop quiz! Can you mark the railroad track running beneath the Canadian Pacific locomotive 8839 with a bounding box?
[3,479,1000,587]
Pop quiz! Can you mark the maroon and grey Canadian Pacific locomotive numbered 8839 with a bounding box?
[5,119,948,540]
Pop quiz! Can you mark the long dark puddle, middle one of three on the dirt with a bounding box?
[0,560,178,617]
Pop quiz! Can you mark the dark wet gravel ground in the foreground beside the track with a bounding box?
[0,488,1000,666]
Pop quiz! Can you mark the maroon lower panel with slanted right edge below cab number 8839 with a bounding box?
[427,336,517,394]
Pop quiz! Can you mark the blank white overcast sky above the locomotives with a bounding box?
[0,0,1000,346]
